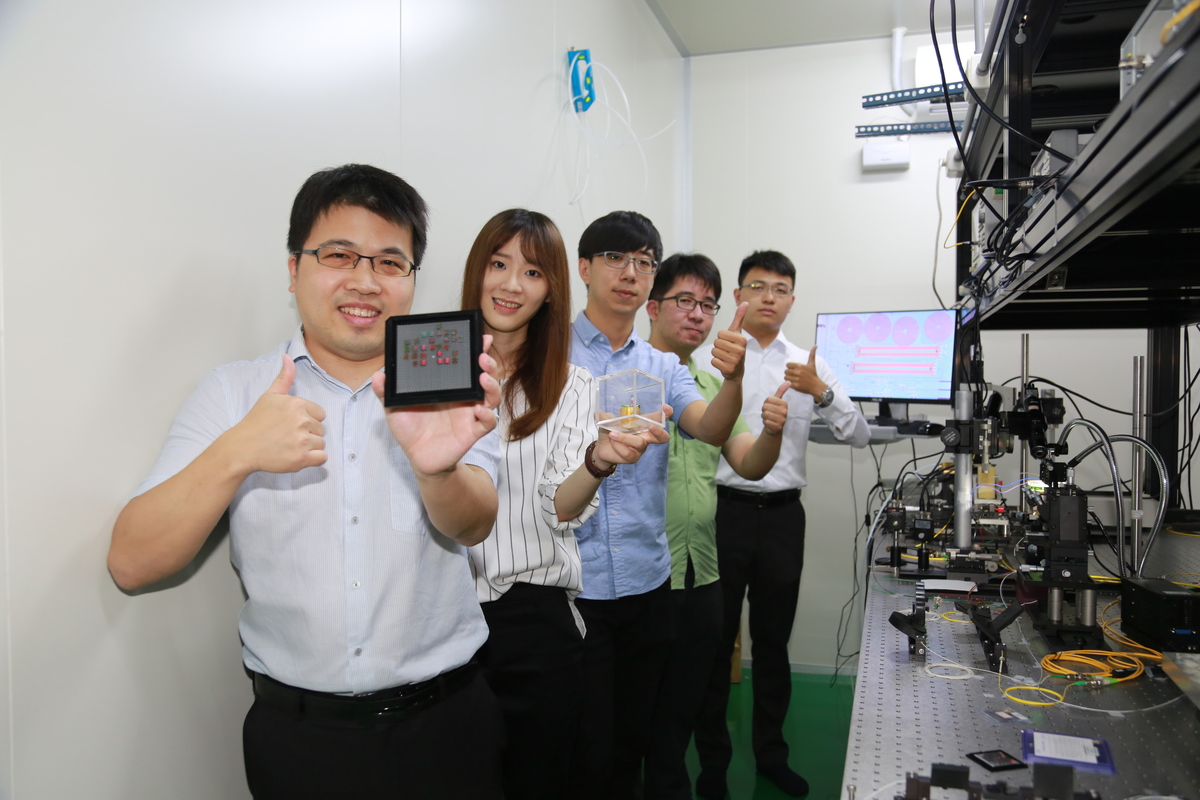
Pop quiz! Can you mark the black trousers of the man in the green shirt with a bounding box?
[646,573,730,800]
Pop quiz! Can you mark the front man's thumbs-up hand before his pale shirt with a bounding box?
[226,354,328,473]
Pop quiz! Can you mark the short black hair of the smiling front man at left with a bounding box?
[288,164,430,264]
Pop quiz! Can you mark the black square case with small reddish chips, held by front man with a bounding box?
[383,309,484,407]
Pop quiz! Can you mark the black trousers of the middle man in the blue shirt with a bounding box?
[566,582,674,800]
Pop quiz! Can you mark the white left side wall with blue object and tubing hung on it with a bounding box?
[0,0,685,800]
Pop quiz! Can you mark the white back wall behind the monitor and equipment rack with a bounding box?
[686,36,1180,669]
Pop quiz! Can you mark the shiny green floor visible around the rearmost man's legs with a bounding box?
[688,669,854,800]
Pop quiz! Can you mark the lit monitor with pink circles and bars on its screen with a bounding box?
[816,308,958,403]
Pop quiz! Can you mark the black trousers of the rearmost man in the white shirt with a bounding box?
[696,498,804,772]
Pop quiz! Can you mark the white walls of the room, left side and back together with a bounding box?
[0,0,1190,800]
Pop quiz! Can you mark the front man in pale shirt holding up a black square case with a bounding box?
[108,164,502,800]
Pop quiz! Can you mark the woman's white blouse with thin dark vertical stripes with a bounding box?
[469,365,600,602]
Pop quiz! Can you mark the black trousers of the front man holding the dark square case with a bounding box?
[242,675,504,800]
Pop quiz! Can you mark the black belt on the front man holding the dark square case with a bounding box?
[254,661,479,722]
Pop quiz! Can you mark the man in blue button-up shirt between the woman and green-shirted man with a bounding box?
[571,211,745,799]
